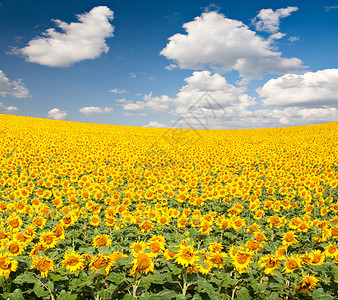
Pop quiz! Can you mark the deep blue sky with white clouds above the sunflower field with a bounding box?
[0,0,338,129]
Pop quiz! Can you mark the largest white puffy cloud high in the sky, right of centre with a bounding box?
[161,11,303,78]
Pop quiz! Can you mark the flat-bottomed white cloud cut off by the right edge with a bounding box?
[256,69,338,107]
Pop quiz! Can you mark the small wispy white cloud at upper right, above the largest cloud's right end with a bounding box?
[253,6,298,33]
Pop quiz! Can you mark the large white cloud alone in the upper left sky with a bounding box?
[15,6,114,67]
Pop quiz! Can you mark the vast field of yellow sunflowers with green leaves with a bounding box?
[0,115,338,300]
